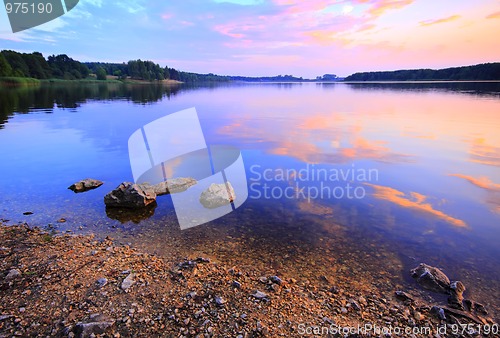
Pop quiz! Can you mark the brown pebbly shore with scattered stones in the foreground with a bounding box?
[0,224,498,337]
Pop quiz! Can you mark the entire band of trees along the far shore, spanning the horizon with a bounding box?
[0,50,500,83]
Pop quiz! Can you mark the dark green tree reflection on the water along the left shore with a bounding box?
[0,82,189,128]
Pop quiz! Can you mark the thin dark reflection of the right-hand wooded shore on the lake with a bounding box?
[336,82,500,97]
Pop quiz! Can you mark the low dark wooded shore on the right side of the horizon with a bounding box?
[345,62,500,81]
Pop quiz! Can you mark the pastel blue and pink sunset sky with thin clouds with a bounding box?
[0,0,500,78]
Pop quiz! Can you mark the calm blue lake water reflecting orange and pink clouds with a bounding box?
[0,83,500,316]
